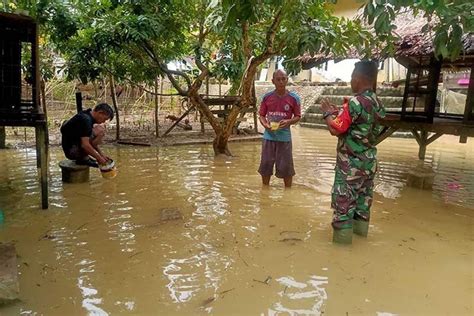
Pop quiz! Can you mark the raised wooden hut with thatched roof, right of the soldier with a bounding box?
[301,12,474,159]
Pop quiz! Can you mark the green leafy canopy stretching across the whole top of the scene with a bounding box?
[5,0,474,87]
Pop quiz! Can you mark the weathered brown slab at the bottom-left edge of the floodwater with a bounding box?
[0,243,20,303]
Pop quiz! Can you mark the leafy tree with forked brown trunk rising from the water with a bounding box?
[26,0,370,154]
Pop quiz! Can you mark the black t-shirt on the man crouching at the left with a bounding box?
[61,109,95,149]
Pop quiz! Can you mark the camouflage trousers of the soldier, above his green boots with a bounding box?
[331,165,375,229]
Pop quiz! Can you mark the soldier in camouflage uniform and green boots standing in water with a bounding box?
[321,61,385,243]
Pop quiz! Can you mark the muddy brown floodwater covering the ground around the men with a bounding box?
[0,127,474,316]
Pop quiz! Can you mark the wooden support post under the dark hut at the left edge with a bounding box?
[35,122,48,209]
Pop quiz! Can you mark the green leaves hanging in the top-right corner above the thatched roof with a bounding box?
[364,0,474,60]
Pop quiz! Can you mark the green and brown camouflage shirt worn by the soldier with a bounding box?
[337,90,385,176]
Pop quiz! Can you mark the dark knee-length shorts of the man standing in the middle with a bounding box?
[258,139,295,178]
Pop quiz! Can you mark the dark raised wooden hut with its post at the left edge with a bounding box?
[0,13,48,209]
